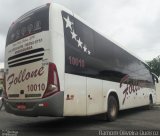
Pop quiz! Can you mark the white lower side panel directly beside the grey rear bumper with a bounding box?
[64,74,86,116]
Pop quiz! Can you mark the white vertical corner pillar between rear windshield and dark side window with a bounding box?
[49,3,72,91]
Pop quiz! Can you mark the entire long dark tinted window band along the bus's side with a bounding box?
[62,12,152,88]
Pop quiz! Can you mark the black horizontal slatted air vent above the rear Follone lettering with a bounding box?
[8,48,44,67]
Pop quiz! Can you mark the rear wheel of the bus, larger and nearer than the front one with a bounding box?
[107,95,118,121]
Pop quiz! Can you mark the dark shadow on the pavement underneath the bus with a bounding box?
[14,107,157,130]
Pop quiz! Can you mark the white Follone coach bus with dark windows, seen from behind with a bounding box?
[4,3,157,121]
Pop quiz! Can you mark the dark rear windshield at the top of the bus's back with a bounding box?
[6,4,49,46]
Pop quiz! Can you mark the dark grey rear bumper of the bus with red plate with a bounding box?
[4,91,64,117]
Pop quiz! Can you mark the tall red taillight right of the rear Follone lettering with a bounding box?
[43,63,60,98]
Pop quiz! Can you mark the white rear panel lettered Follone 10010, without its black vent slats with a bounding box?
[5,31,49,99]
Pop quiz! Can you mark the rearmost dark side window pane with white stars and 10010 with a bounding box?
[62,12,94,75]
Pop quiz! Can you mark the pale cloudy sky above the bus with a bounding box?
[0,0,160,63]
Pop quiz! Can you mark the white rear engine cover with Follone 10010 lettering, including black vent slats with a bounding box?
[5,32,49,99]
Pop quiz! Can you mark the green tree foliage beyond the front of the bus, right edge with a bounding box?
[147,56,160,77]
